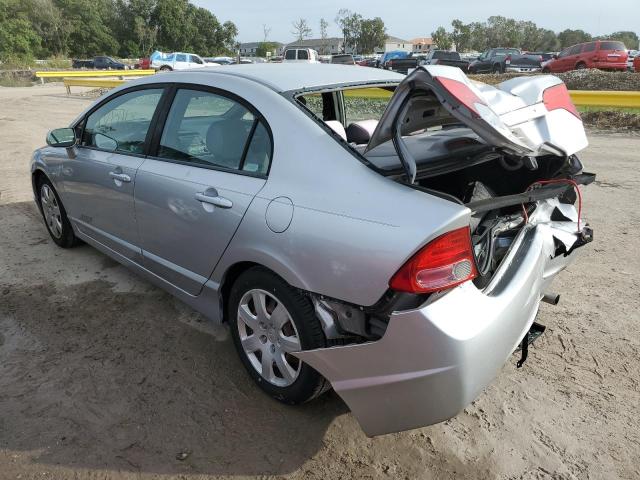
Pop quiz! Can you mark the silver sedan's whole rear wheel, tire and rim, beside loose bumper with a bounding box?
[228,267,329,405]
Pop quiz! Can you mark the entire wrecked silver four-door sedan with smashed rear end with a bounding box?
[31,64,595,435]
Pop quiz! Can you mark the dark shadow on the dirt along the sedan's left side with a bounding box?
[0,204,347,475]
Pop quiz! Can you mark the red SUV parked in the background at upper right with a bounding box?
[542,40,627,73]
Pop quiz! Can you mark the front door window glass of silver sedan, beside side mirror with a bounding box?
[82,88,162,154]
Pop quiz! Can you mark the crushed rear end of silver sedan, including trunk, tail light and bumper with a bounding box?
[296,67,595,436]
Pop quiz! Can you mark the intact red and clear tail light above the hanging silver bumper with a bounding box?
[389,227,478,293]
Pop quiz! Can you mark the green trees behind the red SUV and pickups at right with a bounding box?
[431,16,638,52]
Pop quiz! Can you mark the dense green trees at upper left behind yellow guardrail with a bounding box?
[0,0,238,61]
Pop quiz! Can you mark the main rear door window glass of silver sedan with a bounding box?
[158,89,255,170]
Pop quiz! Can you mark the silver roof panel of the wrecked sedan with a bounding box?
[189,63,405,93]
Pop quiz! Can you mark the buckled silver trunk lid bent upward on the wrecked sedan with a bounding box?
[364,65,587,181]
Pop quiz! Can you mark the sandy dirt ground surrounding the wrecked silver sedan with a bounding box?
[0,85,640,480]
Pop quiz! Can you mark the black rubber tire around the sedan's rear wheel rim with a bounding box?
[228,267,331,405]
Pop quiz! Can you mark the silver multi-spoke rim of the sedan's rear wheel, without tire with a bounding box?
[237,289,302,387]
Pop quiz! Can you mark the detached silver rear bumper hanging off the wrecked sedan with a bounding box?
[296,201,592,436]
